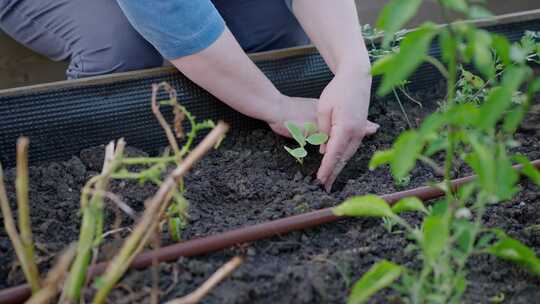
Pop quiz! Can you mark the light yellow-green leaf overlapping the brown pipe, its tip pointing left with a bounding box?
[332,194,394,217]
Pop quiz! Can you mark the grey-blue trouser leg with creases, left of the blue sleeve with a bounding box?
[0,0,163,79]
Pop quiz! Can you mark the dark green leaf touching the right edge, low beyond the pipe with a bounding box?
[486,236,540,276]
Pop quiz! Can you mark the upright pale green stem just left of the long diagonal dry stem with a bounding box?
[64,140,125,302]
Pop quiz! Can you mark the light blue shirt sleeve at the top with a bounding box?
[117,0,225,60]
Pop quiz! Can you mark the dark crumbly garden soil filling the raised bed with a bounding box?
[0,86,540,303]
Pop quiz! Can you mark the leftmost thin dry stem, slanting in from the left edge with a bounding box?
[0,165,40,293]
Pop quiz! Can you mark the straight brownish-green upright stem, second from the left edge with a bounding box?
[15,137,40,292]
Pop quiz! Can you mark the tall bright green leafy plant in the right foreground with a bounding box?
[333,0,540,303]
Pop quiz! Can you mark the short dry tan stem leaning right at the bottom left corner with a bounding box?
[26,244,77,304]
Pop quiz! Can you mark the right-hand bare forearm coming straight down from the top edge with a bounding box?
[293,0,370,78]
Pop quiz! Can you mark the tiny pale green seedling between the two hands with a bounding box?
[284,122,328,164]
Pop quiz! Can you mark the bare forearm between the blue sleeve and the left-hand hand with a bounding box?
[172,29,283,122]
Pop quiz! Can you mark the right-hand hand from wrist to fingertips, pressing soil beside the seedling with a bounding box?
[317,72,379,191]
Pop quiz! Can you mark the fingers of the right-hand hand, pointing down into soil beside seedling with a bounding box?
[317,126,350,184]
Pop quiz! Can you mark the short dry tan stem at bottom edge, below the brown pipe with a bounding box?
[166,256,243,304]
